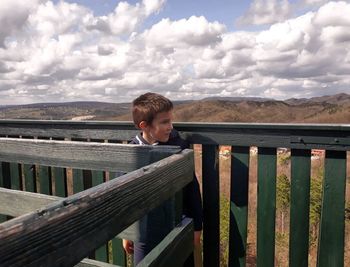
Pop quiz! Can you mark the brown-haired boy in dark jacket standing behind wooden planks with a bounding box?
[123,93,202,265]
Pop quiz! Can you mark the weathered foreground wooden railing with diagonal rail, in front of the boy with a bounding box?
[0,137,194,266]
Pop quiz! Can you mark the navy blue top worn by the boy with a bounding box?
[130,130,203,231]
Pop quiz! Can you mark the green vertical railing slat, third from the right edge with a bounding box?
[257,147,277,267]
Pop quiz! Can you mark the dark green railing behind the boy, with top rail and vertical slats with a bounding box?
[0,121,350,267]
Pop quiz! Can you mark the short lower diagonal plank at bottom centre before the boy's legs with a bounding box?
[137,218,193,267]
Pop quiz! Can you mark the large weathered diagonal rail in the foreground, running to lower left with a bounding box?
[0,150,193,266]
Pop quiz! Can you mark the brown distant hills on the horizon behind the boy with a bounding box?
[0,94,350,123]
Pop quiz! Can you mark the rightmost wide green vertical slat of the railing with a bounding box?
[317,151,346,267]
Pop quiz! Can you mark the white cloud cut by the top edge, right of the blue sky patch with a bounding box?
[237,0,291,25]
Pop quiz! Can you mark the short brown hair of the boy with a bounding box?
[132,92,173,127]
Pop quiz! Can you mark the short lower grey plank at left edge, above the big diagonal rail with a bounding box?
[0,188,61,217]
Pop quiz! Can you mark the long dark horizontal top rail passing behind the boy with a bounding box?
[0,120,350,150]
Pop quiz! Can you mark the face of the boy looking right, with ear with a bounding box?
[143,110,173,144]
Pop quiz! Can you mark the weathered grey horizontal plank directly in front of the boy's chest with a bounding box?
[0,138,180,172]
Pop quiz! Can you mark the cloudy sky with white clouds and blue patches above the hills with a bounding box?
[0,0,350,105]
